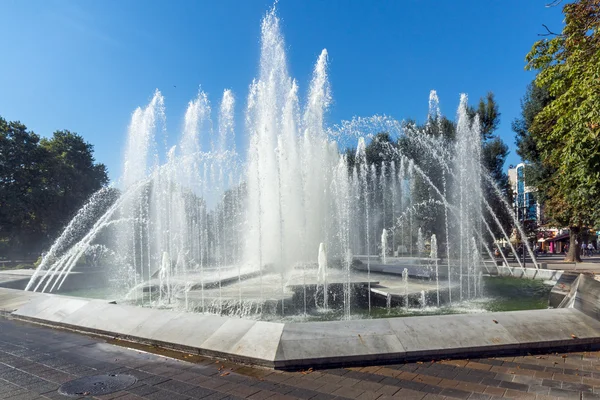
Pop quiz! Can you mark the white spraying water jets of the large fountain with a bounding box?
[26,4,540,320]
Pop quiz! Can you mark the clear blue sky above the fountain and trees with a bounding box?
[0,0,562,179]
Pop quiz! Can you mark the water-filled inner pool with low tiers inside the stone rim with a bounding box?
[9,267,562,322]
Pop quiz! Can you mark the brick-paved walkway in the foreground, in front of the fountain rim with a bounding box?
[0,317,600,400]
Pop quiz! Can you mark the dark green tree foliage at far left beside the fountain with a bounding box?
[0,118,108,257]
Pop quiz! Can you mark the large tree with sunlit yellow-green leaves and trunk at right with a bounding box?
[526,0,600,261]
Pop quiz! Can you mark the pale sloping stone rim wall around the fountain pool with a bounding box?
[0,278,600,369]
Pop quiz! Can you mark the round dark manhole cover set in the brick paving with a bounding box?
[58,375,137,397]
